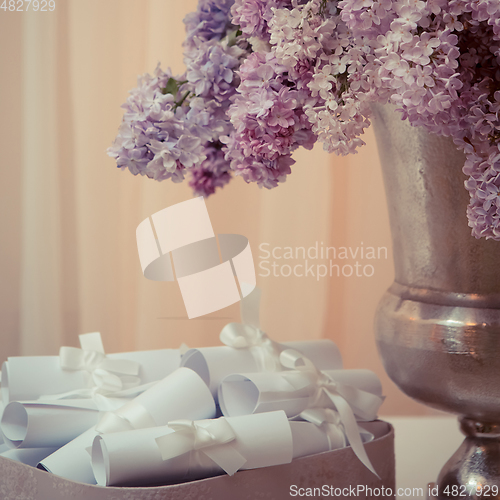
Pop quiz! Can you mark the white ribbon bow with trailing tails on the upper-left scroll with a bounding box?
[39,332,142,410]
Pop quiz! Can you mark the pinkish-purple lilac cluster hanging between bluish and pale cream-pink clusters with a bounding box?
[222,52,316,188]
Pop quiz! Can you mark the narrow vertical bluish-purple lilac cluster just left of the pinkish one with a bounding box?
[184,0,248,196]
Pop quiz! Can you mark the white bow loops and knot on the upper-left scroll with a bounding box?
[59,332,140,396]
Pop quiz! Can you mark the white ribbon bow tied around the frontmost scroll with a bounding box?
[156,417,246,476]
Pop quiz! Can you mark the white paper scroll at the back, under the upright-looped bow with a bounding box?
[181,339,342,398]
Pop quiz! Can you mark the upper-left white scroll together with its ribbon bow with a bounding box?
[1,333,180,404]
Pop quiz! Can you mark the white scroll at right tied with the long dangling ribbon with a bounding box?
[218,370,383,419]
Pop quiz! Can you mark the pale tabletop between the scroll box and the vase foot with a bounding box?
[381,416,464,500]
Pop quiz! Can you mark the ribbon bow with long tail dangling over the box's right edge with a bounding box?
[280,349,382,477]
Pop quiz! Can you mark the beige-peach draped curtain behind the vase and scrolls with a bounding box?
[0,0,431,415]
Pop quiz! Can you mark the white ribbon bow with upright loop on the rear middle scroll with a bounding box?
[220,288,282,371]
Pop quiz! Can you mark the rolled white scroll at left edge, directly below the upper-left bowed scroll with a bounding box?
[0,398,128,450]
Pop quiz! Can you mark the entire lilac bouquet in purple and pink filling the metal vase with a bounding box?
[109,0,500,240]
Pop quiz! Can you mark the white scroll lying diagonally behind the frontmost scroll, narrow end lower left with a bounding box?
[39,368,216,484]
